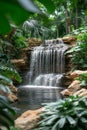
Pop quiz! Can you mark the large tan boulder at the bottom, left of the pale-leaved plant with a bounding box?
[15,108,44,130]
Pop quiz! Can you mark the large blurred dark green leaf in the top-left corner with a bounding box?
[0,0,32,34]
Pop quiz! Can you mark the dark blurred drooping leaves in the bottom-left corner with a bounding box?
[0,96,16,130]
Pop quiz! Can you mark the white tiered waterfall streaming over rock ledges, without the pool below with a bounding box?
[26,39,67,86]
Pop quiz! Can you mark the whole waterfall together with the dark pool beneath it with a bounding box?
[16,39,68,110]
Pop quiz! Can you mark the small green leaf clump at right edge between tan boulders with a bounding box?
[75,73,87,88]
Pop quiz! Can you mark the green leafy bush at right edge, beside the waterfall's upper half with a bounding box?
[66,33,87,69]
